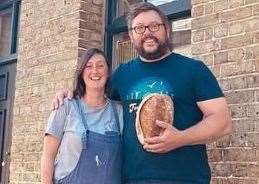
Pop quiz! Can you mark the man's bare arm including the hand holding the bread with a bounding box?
[144,97,232,153]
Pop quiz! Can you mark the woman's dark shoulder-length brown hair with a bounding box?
[73,48,110,98]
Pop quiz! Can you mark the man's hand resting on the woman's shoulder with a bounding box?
[52,89,73,110]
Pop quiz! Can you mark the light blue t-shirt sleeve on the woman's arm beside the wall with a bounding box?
[45,102,68,140]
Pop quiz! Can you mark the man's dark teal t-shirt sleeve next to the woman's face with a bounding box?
[109,66,121,101]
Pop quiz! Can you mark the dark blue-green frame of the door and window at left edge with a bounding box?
[0,0,21,184]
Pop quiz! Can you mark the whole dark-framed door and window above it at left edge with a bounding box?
[0,0,20,183]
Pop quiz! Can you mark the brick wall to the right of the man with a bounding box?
[192,0,259,184]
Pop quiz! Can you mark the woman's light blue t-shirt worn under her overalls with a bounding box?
[46,99,123,180]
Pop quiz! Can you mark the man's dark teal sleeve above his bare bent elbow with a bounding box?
[194,62,224,102]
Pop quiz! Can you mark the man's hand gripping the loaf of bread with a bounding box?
[143,120,185,153]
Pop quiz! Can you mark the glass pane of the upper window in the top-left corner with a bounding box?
[0,9,12,57]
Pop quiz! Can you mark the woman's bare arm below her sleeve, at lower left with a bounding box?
[41,134,60,184]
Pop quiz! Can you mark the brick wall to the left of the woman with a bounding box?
[10,0,103,184]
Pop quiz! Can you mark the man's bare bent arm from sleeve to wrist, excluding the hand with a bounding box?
[183,97,232,145]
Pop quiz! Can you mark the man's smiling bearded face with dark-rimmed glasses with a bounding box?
[129,10,170,60]
